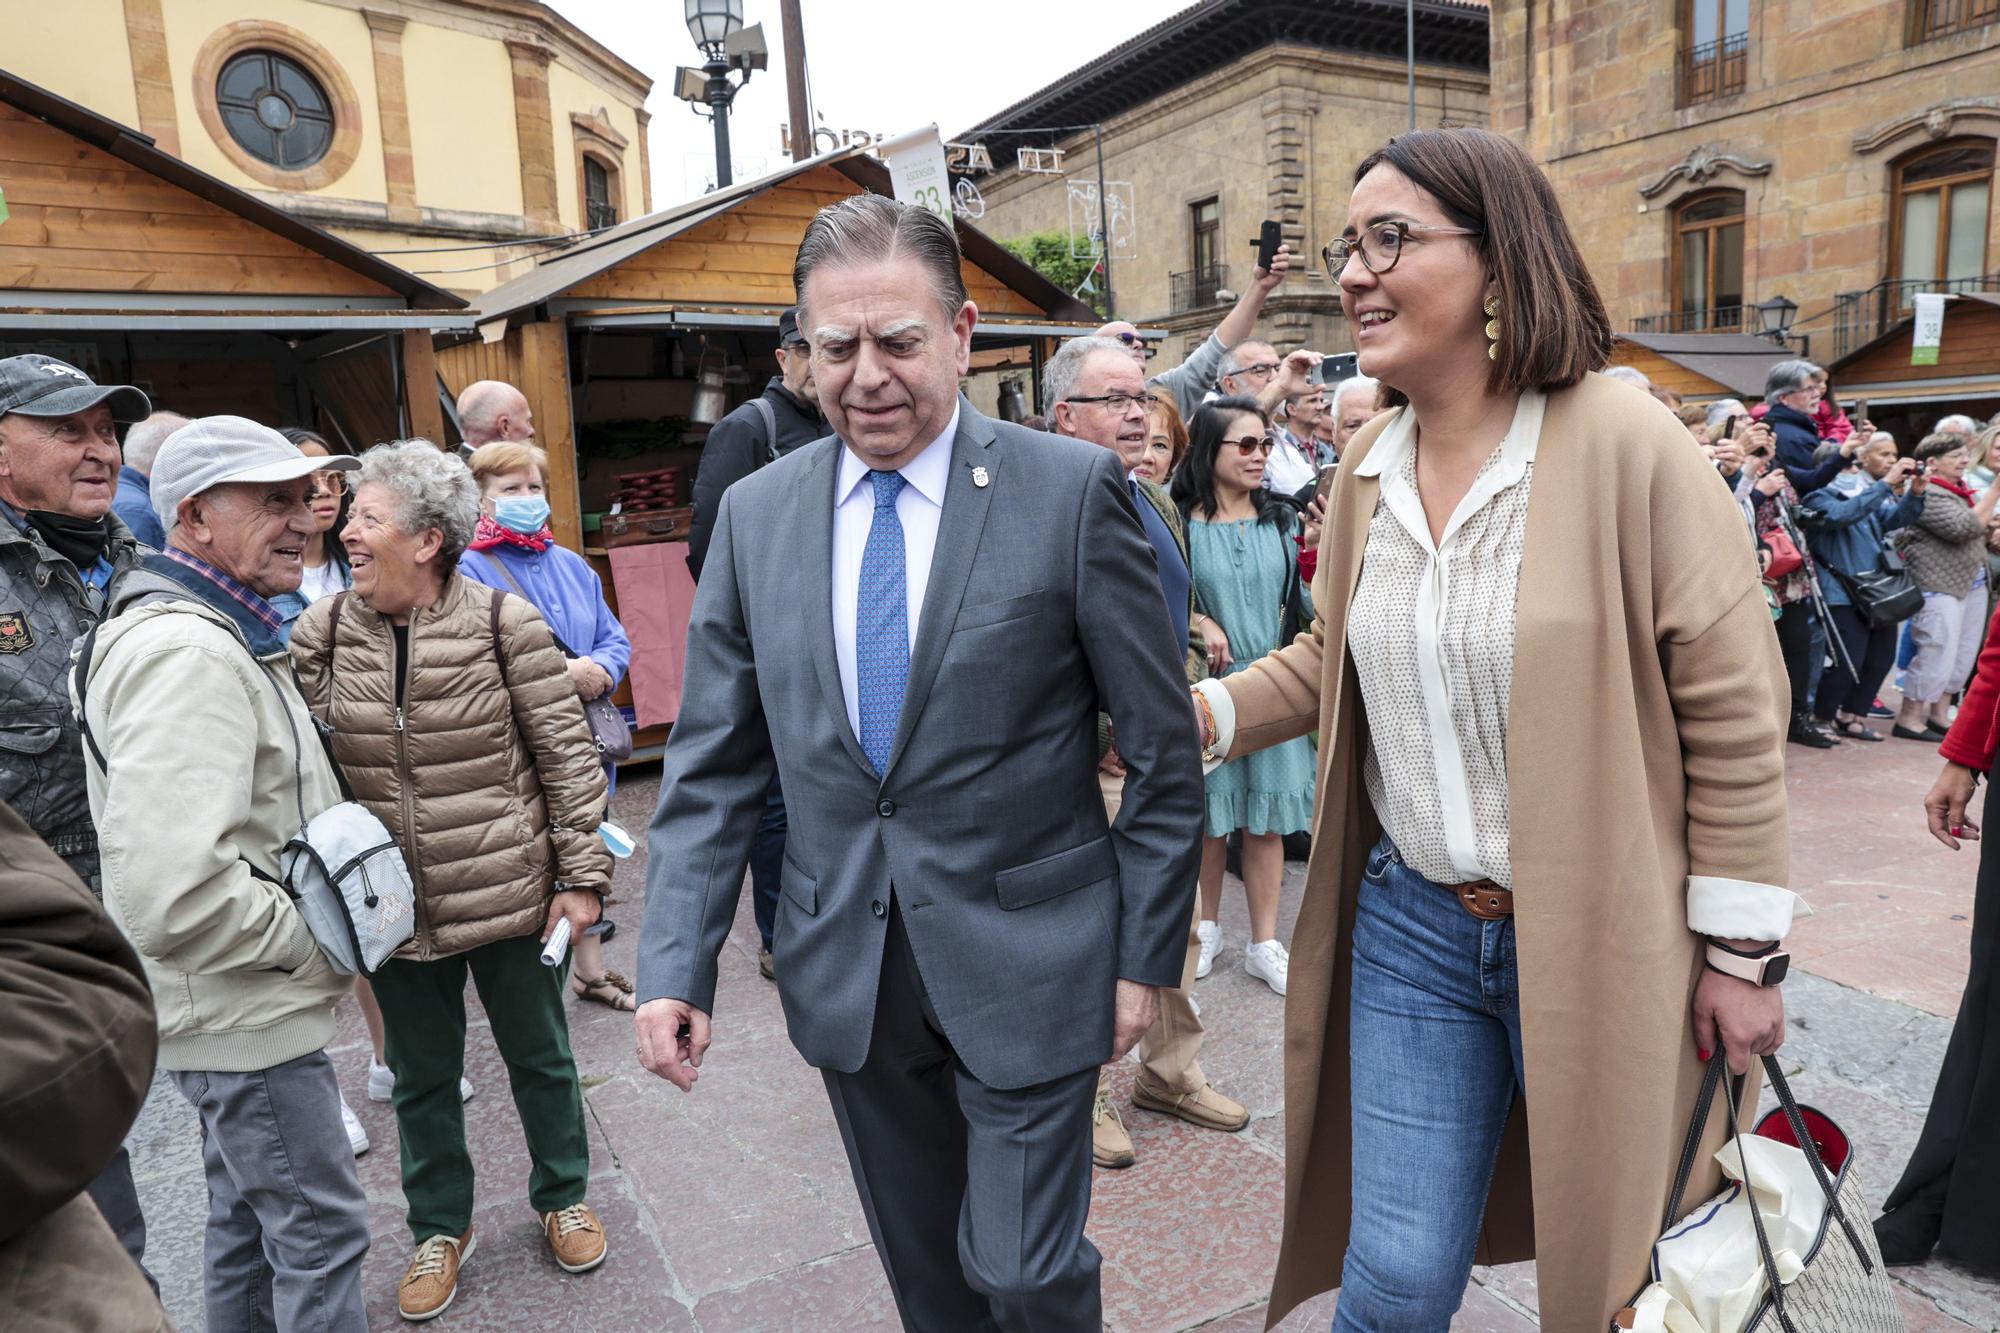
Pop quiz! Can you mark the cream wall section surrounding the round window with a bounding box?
[164,0,388,202]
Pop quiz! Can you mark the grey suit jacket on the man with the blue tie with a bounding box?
[638,400,1202,1089]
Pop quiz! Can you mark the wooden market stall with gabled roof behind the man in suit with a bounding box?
[438,148,1098,759]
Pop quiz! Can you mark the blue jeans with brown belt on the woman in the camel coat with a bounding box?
[1334,837,1522,1333]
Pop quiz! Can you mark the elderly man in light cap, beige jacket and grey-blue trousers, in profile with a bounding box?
[72,416,368,1333]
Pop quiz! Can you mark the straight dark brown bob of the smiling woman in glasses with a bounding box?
[1354,128,1612,406]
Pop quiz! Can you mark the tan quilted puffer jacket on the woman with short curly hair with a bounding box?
[292,572,612,961]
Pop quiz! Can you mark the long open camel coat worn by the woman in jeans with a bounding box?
[1224,374,1790,1333]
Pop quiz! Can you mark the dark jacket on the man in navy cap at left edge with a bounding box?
[0,506,144,893]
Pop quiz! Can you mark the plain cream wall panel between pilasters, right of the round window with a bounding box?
[402,22,520,214]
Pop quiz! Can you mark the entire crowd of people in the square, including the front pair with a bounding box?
[0,130,2000,1333]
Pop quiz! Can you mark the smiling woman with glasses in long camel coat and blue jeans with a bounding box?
[1196,130,1796,1333]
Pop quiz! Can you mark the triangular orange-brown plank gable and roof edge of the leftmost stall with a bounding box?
[0,70,468,314]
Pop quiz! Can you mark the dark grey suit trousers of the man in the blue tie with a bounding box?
[820,899,1104,1333]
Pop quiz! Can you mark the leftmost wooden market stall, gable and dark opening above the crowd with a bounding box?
[0,70,472,452]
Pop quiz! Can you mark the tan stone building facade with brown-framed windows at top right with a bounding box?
[1492,0,2000,362]
